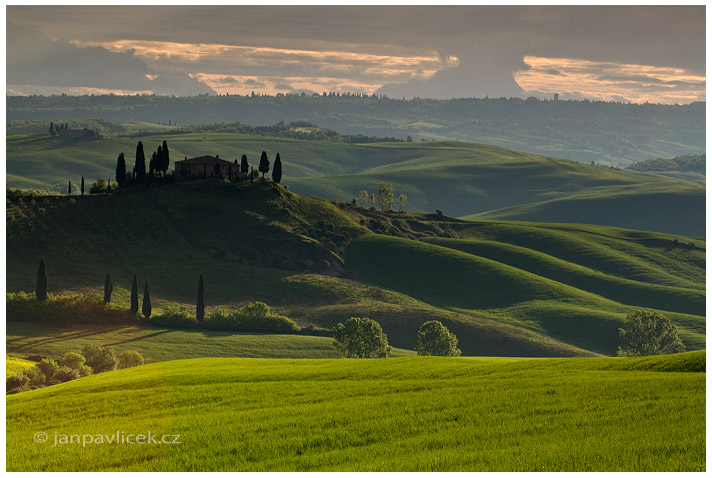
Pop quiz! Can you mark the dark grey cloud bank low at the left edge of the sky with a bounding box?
[6,22,214,95]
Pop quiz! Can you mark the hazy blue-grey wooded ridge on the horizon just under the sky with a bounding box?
[6,95,705,167]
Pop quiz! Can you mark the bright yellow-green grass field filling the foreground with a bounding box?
[7,352,706,471]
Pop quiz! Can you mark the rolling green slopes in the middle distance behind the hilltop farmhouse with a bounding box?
[6,133,705,236]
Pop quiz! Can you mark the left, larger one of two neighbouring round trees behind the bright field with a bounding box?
[334,317,391,358]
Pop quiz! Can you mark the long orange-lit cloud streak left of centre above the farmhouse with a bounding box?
[75,40,459,94]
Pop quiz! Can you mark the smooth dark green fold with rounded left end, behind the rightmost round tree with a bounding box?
[345,235,705,355]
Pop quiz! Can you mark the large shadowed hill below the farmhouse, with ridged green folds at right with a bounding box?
[6,181,705,356]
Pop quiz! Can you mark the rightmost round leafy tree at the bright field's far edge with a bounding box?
[618,310,685,357]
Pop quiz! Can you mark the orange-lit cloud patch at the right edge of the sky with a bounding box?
[514,56,706,104]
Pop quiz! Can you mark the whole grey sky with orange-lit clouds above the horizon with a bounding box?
[6,5,706,104]
